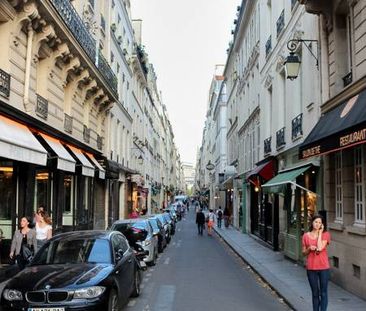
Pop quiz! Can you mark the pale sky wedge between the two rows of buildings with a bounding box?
[131,0,241,164]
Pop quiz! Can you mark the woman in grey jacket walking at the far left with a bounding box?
[9,217,37,270]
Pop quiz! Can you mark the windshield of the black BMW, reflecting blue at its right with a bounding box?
[32,239,112,265]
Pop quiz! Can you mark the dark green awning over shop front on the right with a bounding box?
[262,165,310,193]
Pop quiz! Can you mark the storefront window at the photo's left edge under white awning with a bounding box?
[0,161,16,239]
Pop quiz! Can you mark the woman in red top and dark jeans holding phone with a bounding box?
[302,215,330,311]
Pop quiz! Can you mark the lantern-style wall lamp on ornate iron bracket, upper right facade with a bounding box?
[284,39,319,80]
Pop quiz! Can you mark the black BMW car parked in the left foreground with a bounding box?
[1,231,141,311]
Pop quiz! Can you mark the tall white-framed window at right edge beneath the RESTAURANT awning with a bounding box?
[353,145,366,227]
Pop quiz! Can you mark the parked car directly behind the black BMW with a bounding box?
[111,218,158,265]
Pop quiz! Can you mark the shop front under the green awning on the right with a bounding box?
[262,164,319,261]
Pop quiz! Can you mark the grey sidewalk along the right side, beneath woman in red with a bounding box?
[215,227,366,311]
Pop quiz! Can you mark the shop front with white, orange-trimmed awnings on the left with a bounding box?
[0,114,104,262]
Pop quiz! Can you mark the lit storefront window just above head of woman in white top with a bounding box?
[33,170,51,213]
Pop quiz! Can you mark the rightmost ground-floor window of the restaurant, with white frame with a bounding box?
[354,146,365,225]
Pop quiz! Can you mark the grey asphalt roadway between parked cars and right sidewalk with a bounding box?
[125,209,290,311]
